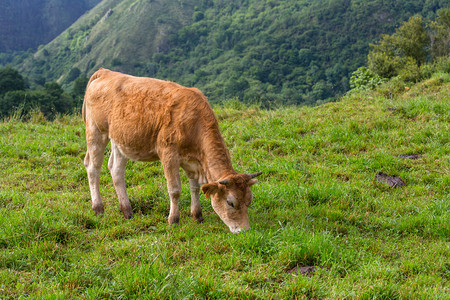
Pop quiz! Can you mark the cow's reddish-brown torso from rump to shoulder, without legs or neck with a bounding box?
[84,69,216,160]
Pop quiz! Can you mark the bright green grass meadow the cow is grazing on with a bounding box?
[0,74,450,299]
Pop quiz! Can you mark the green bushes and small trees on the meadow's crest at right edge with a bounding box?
[350,8,450,90]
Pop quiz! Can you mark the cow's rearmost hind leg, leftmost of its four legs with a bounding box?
[84,125,109,214]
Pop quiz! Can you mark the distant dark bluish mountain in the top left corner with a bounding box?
[0,0,101,52]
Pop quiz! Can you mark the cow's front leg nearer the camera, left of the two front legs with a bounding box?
[161,153,181,225]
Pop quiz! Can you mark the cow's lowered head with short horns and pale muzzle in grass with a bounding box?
[202,172,262,233]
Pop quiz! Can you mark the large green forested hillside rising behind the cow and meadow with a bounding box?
[7,0,448,105]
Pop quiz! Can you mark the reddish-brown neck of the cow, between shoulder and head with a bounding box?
[202,129,236,182]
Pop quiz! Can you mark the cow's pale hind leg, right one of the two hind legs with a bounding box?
[108,141,133,219]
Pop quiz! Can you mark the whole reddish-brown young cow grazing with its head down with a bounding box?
[83,69,261,232]
